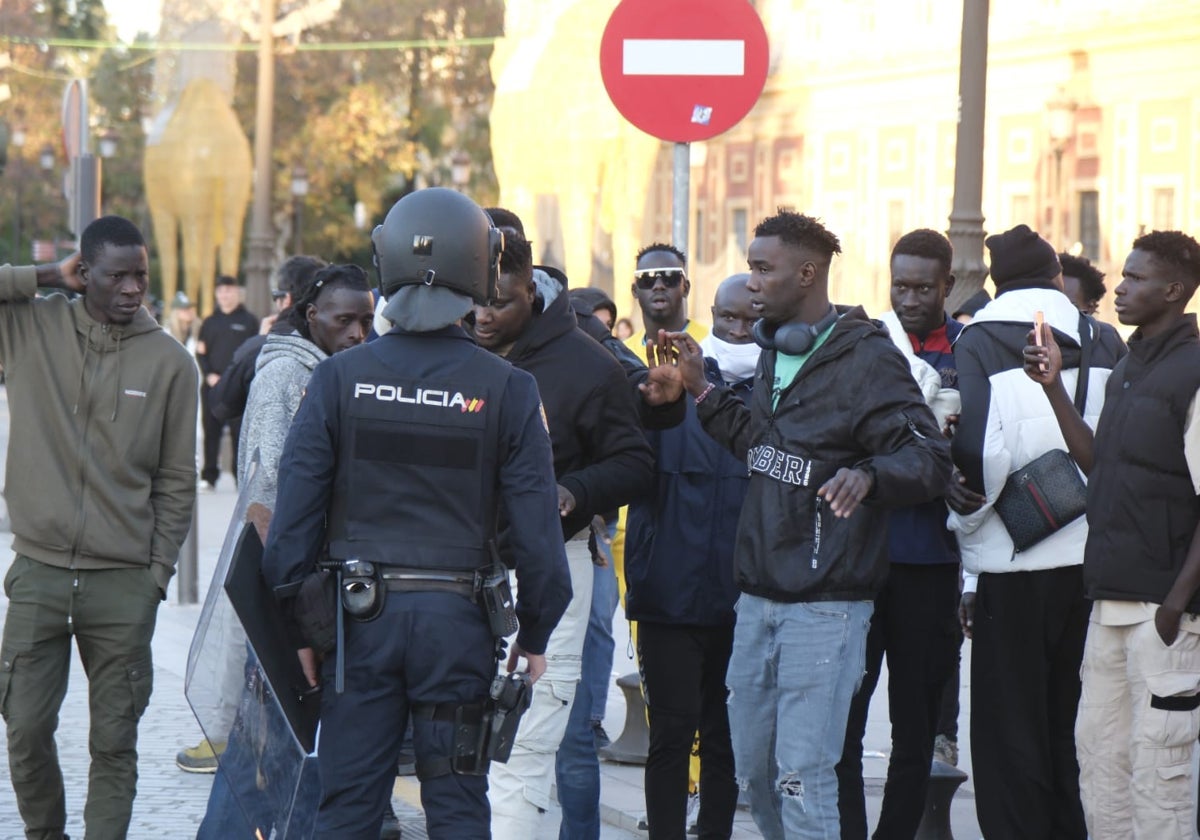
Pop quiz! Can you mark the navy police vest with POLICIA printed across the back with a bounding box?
[329,337,511,571]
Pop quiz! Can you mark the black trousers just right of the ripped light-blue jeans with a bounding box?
[838,563,959,840]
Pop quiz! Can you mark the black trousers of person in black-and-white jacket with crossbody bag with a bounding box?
[971,565,1091,840]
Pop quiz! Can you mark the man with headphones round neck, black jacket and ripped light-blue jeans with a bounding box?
[643,211,950,838]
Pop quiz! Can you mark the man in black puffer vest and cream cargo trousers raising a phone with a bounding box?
[1024,230,1200,840]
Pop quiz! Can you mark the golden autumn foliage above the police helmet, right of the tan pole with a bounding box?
[247,0,504,264]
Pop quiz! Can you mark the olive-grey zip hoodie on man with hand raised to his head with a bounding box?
[0,265,199,593]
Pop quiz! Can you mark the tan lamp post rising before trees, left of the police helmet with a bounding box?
[246,0,275,317]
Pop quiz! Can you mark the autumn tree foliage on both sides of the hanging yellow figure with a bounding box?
[0,0,504,268]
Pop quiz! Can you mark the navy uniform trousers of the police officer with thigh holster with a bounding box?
[313,592,496,840]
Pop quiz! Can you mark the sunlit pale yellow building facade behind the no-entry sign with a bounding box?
[492,0,1200,318]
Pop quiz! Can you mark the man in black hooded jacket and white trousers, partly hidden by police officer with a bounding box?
[475,226,654,840]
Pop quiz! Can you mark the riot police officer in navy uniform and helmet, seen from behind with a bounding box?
[263,188,571,840]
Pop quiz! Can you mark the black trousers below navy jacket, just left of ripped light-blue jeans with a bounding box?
[637,622,738,840]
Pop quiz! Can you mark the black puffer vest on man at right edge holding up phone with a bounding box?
[1084,316,1200,612]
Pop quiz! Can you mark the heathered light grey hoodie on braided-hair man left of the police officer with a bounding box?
[238,332,328,511]
